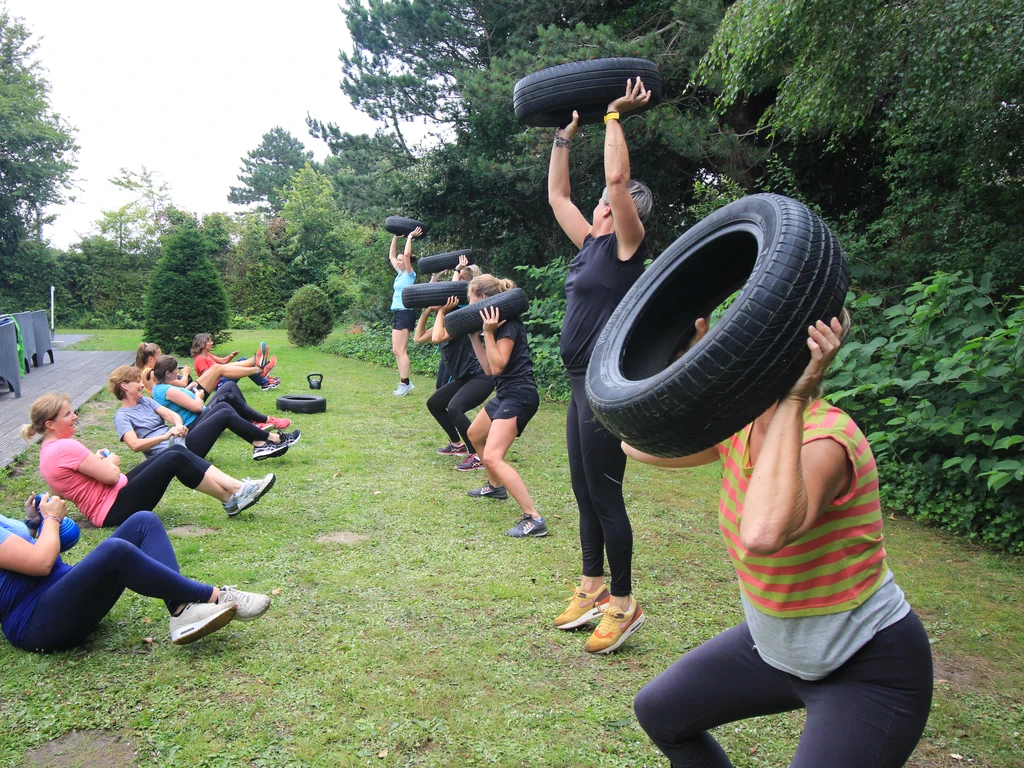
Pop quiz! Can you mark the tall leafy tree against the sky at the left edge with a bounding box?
[0,11,78,304]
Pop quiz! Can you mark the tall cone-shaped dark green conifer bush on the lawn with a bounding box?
[144,224,230,356]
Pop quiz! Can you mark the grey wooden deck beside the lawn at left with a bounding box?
[0,344,135,468]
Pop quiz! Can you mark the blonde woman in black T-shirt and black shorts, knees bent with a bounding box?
[437,274,548,539]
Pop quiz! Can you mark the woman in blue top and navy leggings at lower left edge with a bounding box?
[0,495,270,652]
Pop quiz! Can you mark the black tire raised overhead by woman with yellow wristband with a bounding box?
[512,58,662,128]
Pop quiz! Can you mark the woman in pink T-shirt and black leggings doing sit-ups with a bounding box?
[22,392,276,528]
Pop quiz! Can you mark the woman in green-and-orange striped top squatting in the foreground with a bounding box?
[623,310,932,768]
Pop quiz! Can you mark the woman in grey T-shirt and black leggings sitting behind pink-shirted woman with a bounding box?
[108,366,297,461]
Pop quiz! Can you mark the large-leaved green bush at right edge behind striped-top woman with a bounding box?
[829,272,1024,553]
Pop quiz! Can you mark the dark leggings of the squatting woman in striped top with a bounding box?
[633,611,932,768]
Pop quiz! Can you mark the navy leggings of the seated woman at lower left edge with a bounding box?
[17,512,213,651]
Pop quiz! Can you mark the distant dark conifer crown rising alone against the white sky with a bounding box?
[227,126,313,213]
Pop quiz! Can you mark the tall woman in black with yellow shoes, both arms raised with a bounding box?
[548,78,652,653]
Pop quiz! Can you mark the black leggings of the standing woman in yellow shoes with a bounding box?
[565,372,633,597]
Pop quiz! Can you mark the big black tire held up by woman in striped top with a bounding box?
[587,195,850,457]
